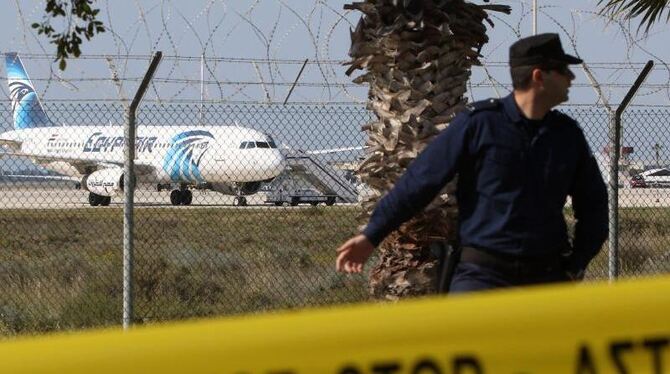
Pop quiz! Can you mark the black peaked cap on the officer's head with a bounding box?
[509,33,582,67]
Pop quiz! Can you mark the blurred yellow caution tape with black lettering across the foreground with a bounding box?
[0,277,670,374]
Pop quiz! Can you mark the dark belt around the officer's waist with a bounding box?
[461,247,563,275]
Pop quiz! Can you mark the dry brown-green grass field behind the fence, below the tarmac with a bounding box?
[0,206,670,336]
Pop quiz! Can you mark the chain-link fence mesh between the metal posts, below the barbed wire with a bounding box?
[0,103,670,335]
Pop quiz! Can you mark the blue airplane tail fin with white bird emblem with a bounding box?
[5,52,51,130]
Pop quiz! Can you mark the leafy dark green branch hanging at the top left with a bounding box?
[32,0,105,70]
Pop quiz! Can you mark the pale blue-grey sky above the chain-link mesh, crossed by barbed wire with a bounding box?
[0,0,670,107]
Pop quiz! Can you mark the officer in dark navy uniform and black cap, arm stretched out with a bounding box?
[336,34,607,292]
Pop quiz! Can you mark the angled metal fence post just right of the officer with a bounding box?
[608,60,654,282]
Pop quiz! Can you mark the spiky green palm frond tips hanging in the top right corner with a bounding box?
[598,0,670,33]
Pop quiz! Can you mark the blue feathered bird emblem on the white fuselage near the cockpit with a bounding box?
[163,130,214,183]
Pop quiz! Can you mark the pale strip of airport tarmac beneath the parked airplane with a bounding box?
[0,184,670,209]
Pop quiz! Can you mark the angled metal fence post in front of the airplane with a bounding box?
[123,52,163,329]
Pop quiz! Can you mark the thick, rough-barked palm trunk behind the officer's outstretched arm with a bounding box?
[345,0,510,299]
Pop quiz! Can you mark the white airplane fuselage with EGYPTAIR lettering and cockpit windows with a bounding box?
[2,126,284,184]
